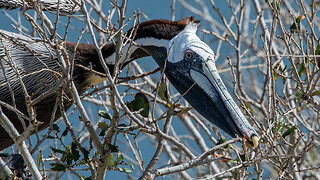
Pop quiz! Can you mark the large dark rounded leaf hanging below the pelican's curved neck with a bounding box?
[127,93,150,117]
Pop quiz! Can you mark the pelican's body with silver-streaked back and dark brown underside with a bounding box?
[0,30,70,150]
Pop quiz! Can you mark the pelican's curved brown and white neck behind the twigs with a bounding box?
[66,18,193,90]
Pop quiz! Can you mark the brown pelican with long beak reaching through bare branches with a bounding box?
[0,17,259,150]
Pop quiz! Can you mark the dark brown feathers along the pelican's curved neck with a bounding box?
[66,17,199,73]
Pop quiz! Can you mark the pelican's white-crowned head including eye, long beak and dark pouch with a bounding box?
[139,18,259,146]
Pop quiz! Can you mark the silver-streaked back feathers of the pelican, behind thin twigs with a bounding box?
[0,31,61,105]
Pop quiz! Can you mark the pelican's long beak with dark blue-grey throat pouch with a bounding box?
[141,45,259,147]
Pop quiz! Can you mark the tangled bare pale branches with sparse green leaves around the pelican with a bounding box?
[0,0,320,179]
